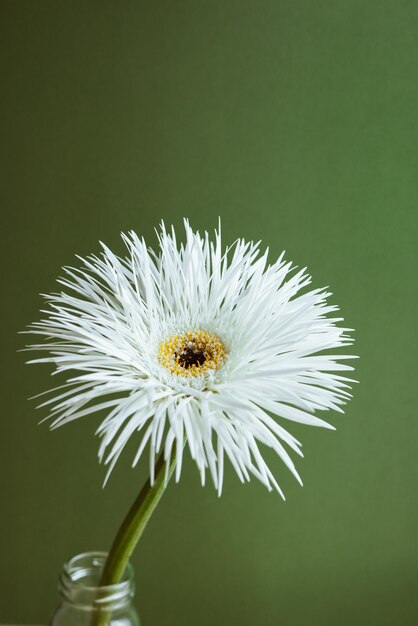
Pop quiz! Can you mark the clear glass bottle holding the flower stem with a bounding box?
[50,552,139,626]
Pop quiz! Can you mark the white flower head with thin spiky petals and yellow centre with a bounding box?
[29,221,352,496]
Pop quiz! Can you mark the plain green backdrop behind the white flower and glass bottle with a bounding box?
[0,0,418,626]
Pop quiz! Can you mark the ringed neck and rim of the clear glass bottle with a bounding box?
[59,552,135,611]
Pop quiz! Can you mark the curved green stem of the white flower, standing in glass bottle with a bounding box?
[93,445,176,626]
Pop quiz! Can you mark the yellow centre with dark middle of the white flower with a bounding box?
[158,330,227,378]
